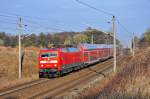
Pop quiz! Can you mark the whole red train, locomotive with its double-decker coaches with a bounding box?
[38,44,113,78]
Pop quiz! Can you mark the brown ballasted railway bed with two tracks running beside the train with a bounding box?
[0,55,127,99]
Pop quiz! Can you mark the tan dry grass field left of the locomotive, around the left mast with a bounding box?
[0,47,38,89]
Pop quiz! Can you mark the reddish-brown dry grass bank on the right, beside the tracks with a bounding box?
[96,51,150,98]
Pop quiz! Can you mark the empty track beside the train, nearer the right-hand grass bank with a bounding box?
[30,62,113,99]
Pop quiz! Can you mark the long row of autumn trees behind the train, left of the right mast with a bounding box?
[0,27,114,47]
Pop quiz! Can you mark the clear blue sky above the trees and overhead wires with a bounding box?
[0,0,150,45]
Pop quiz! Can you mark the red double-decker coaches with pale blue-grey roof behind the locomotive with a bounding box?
[79,44,113,64]
